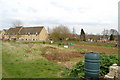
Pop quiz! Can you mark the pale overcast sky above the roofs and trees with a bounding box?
[0,0,119,34]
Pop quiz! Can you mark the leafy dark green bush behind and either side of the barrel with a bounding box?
[70,54,120,77]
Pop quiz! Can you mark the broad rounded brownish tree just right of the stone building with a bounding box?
[50,25,71,41]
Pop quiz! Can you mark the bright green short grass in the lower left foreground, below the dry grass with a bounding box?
[3,59,62,78]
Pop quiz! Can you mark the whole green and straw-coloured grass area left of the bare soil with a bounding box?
[2,43,65,78]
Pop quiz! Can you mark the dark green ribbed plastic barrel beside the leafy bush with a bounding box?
[84,52,100,78]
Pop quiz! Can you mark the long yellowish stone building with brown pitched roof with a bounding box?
[5,26,48,41]
